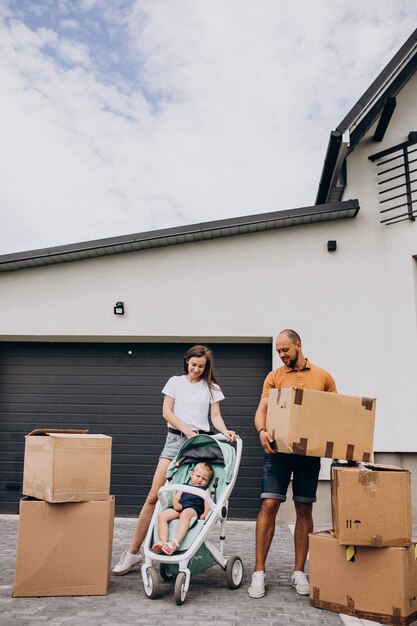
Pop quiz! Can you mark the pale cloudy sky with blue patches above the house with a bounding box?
[0,0,417,255]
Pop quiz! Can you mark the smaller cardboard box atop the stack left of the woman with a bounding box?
[23,429,112,502]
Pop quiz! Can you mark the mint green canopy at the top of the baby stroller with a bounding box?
[167,435,236,483]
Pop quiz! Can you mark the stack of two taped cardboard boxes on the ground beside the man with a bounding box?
[310,463,417,625]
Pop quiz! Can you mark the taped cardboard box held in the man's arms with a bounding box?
[267,387,376,461]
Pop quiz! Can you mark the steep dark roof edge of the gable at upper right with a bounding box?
[316,29,417,204]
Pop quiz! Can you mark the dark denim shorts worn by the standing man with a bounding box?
[261,452,320,503]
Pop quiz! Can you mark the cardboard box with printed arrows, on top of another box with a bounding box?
[331,463,412,547]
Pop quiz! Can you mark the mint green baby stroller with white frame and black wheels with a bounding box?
[142,435,243,604]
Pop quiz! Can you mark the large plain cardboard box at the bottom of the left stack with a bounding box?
[13,496,114,598]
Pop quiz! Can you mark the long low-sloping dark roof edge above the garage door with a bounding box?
[0,200,359,272]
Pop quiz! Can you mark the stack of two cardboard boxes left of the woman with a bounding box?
[13,430,114,597]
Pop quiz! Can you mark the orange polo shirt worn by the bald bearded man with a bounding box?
[261,359,337,398]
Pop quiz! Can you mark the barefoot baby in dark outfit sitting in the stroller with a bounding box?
[152,462,213,556]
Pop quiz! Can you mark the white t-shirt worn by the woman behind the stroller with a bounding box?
[162,374,224,430]
